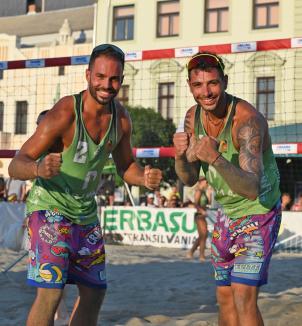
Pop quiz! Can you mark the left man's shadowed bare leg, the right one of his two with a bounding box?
[69,284,106,326]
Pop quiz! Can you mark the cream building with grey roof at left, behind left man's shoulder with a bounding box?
[0,1,96,175]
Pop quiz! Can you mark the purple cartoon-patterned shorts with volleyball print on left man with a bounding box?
[27,211,106,288]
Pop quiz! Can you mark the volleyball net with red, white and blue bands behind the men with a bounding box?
[0,40,302,196]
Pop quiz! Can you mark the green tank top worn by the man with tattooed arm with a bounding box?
[194,94,280,219]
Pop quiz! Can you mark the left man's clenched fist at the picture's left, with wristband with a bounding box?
[37,153,62,179]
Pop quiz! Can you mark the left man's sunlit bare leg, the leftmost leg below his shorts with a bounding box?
[26,288,63,326]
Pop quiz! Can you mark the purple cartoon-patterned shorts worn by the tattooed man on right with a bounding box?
[211,203,281,286]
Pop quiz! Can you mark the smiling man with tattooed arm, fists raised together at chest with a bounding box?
[173,52,281,326]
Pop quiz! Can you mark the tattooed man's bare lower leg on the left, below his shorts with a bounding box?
[216,286,239,326]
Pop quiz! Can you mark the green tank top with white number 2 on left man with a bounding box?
[26,93,117,225]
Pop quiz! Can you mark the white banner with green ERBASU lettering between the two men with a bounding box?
[101,206,197,248]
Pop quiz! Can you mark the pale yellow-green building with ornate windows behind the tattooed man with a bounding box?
[96,0,302,142]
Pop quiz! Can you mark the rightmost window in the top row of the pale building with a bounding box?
[253,0,279,29]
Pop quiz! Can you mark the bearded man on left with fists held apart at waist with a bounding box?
[9,44,162,326]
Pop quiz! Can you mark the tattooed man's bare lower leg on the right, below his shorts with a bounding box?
[232,283,264,326]
